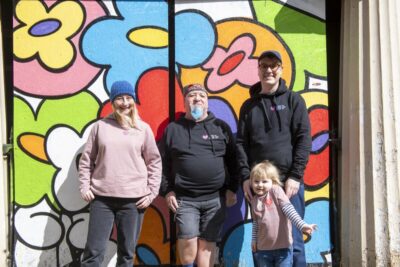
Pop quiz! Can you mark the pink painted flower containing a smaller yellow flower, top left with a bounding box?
[13,0,106,96]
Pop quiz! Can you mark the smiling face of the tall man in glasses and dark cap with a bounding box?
[258,57,282,86]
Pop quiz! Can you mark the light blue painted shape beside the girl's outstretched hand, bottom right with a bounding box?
[304,200,331,263]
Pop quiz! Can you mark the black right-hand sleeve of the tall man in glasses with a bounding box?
[289,93,311,181]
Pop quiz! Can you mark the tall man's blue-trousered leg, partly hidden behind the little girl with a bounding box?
[290,184,306,267]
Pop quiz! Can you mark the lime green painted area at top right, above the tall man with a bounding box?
[253,1,327,91]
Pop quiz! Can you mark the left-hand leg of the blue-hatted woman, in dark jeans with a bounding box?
[81,197,114,267]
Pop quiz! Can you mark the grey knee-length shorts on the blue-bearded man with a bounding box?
[175,197,226,242]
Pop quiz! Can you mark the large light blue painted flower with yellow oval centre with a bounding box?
[82,1,215,96]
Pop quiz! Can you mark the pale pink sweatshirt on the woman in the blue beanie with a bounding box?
[79,116,162,200]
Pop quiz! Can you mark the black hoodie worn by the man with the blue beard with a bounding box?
[160,112,238,201]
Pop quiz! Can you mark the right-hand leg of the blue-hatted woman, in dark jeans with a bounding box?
[115,199,144,267]
